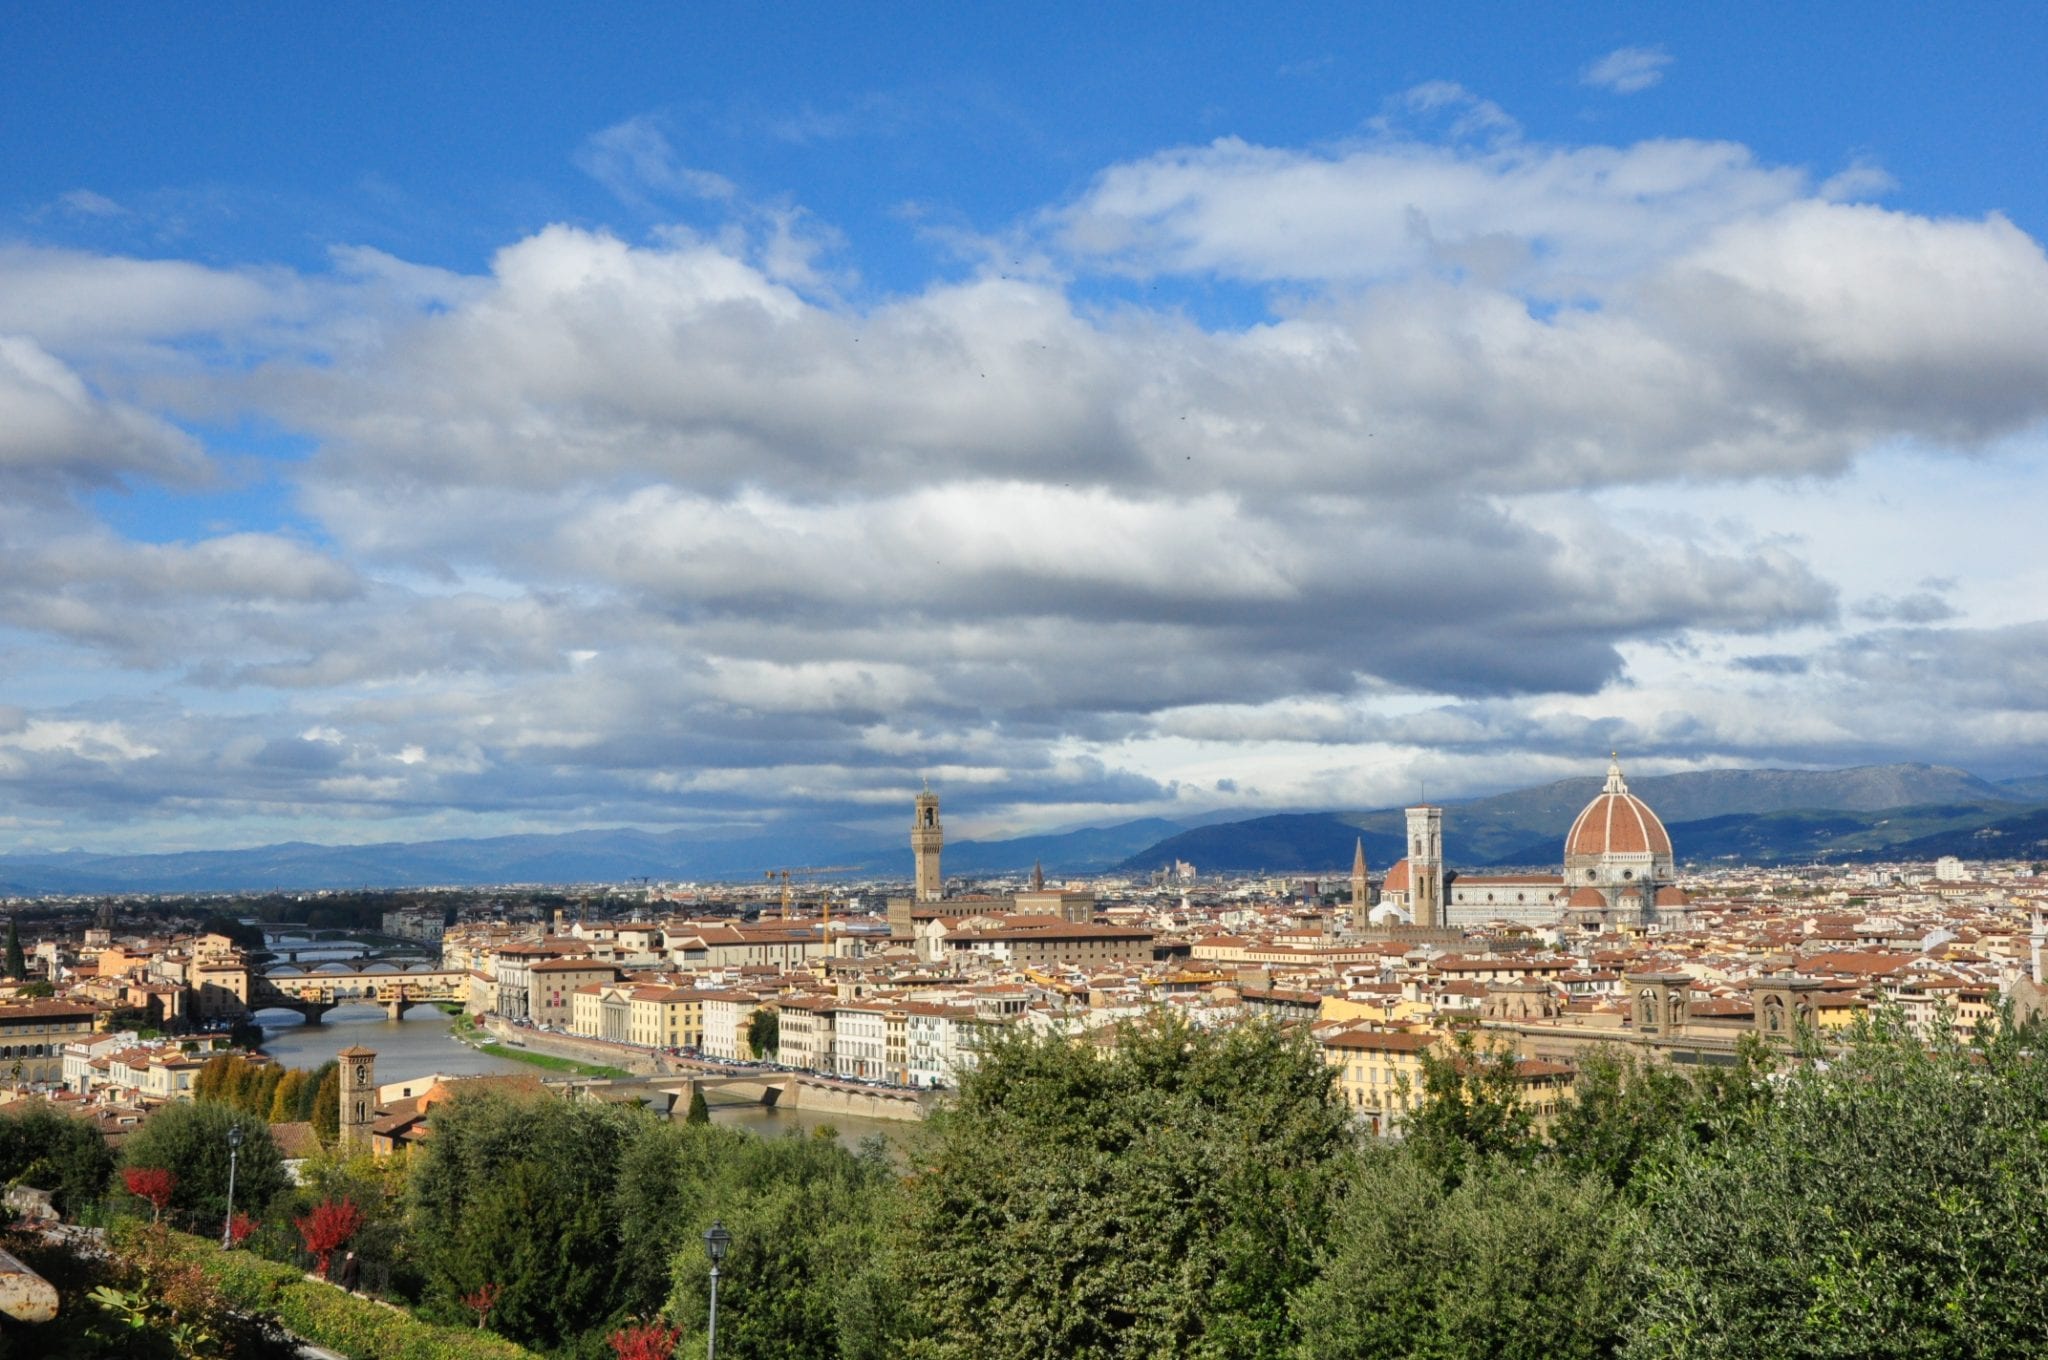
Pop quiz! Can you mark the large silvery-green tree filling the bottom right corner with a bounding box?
[1626,1012,2048,1360]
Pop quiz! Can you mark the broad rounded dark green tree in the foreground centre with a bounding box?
[905,1014,1352,1360]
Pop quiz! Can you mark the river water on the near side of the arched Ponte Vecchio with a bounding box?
[256,987,913,1147]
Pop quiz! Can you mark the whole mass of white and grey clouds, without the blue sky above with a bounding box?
[0,103,2048,844]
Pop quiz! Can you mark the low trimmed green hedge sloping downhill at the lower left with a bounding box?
[141,1233,535,1360]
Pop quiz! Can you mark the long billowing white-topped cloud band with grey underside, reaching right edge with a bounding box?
[256,205,2048,524]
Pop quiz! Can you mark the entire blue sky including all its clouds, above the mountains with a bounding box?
[0,4,2048,848]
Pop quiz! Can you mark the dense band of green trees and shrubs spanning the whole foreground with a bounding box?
[0,1016,2048,1360]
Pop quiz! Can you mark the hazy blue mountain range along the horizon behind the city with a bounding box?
[0,764,2048,895]
